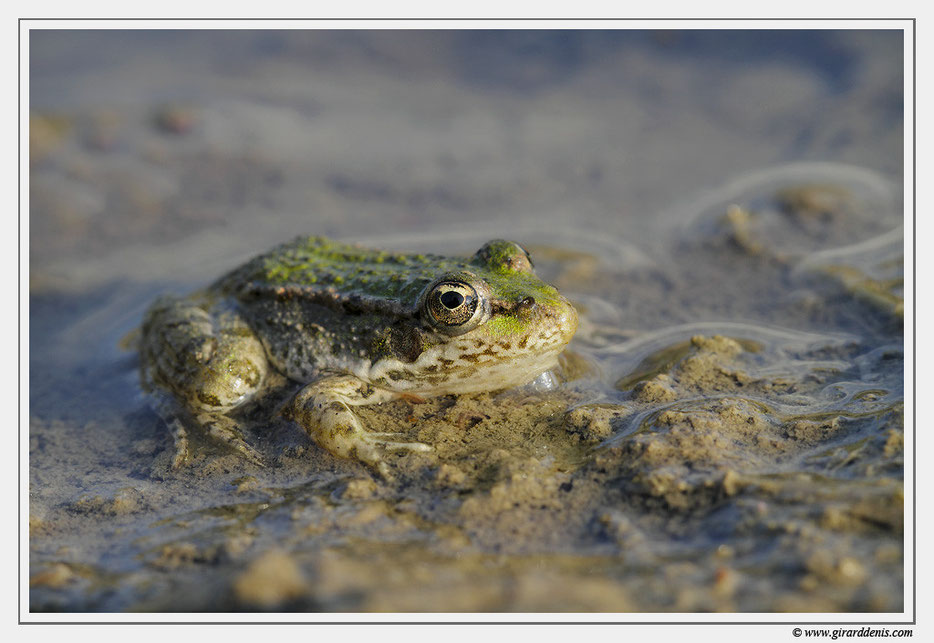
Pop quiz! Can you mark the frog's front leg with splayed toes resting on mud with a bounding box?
[290,375,431,474]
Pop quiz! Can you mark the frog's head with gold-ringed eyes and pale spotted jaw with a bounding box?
[372,240,577,394]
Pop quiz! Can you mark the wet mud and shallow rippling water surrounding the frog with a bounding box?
[28,32,904,612]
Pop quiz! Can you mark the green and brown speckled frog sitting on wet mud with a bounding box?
[139,236,578,475]
